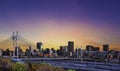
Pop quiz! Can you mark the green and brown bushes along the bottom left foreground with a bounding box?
[0,59,75,71]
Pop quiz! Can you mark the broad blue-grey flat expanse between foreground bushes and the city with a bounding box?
[20,59,120,71]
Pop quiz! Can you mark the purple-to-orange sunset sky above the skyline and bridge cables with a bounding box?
[0,0,120,50]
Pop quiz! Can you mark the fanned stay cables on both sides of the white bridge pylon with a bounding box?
[0,31,35,50]
